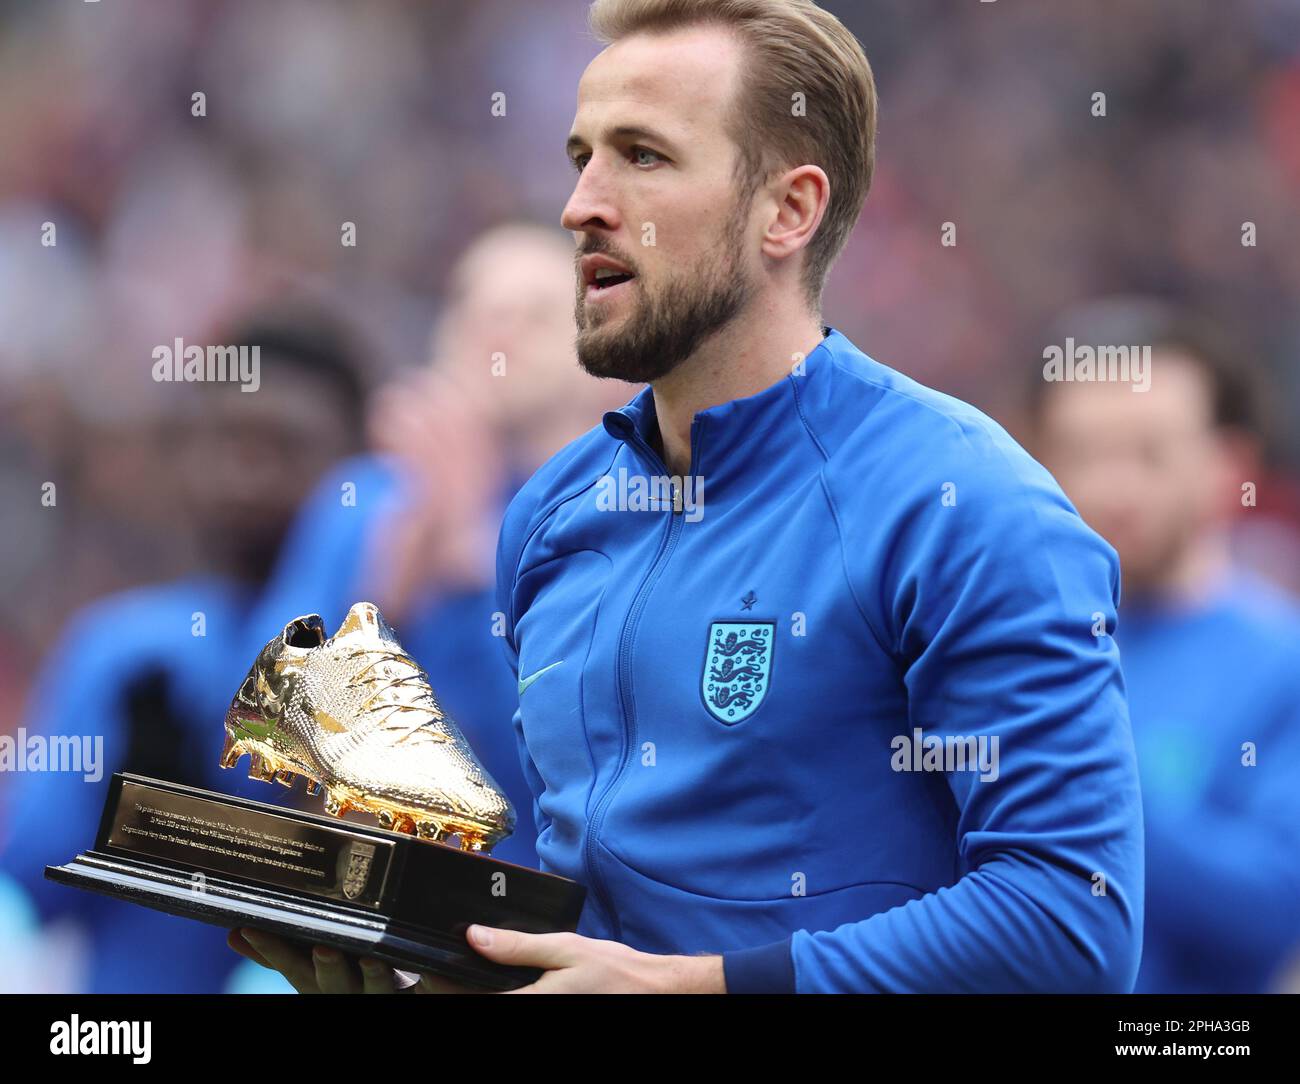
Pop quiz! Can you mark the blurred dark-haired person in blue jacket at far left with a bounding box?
[0,308,364,993]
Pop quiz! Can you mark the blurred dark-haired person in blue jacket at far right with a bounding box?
[1032,298,1300,993]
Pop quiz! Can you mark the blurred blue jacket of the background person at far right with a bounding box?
[1115,568,1300,993]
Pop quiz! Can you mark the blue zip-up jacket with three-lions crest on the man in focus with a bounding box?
[498,329,1143,993]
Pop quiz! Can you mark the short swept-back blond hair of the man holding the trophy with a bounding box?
[588,0,876,311]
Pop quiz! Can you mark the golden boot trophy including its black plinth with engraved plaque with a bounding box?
[46,602,586,989]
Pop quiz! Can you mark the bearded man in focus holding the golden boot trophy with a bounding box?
[239,0,1143,993]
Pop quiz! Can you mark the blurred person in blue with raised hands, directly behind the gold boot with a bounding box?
[238,222,627,867]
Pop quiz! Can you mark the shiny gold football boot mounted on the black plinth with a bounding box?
[221,602,515,853]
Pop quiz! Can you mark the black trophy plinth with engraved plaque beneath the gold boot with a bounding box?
[46,772,585,990]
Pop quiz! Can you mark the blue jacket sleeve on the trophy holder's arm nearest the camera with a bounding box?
[748,434,1144,993]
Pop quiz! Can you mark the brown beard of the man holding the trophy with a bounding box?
[573,200,757,383]
